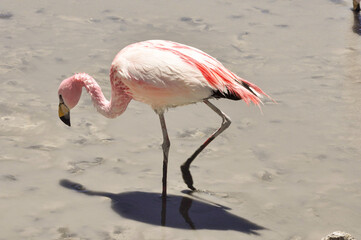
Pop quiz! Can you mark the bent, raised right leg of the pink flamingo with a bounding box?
[181,100,231,191]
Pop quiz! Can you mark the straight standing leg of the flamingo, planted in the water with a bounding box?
[159,113,170,199]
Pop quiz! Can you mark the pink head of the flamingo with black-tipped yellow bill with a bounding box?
[58,75,82,127]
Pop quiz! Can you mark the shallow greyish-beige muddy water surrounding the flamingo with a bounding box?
[0,0,361,240]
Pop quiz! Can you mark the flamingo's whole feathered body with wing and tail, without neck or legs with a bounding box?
[112,40,267,108]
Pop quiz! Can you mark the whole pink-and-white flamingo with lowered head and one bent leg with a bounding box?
[58,40,269,198]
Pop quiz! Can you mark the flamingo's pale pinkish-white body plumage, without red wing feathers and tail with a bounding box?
[111,42,212,112]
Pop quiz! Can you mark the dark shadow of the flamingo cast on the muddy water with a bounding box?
[60,180,265,235]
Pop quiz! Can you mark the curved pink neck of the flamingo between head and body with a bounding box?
[74,73,131,118]
